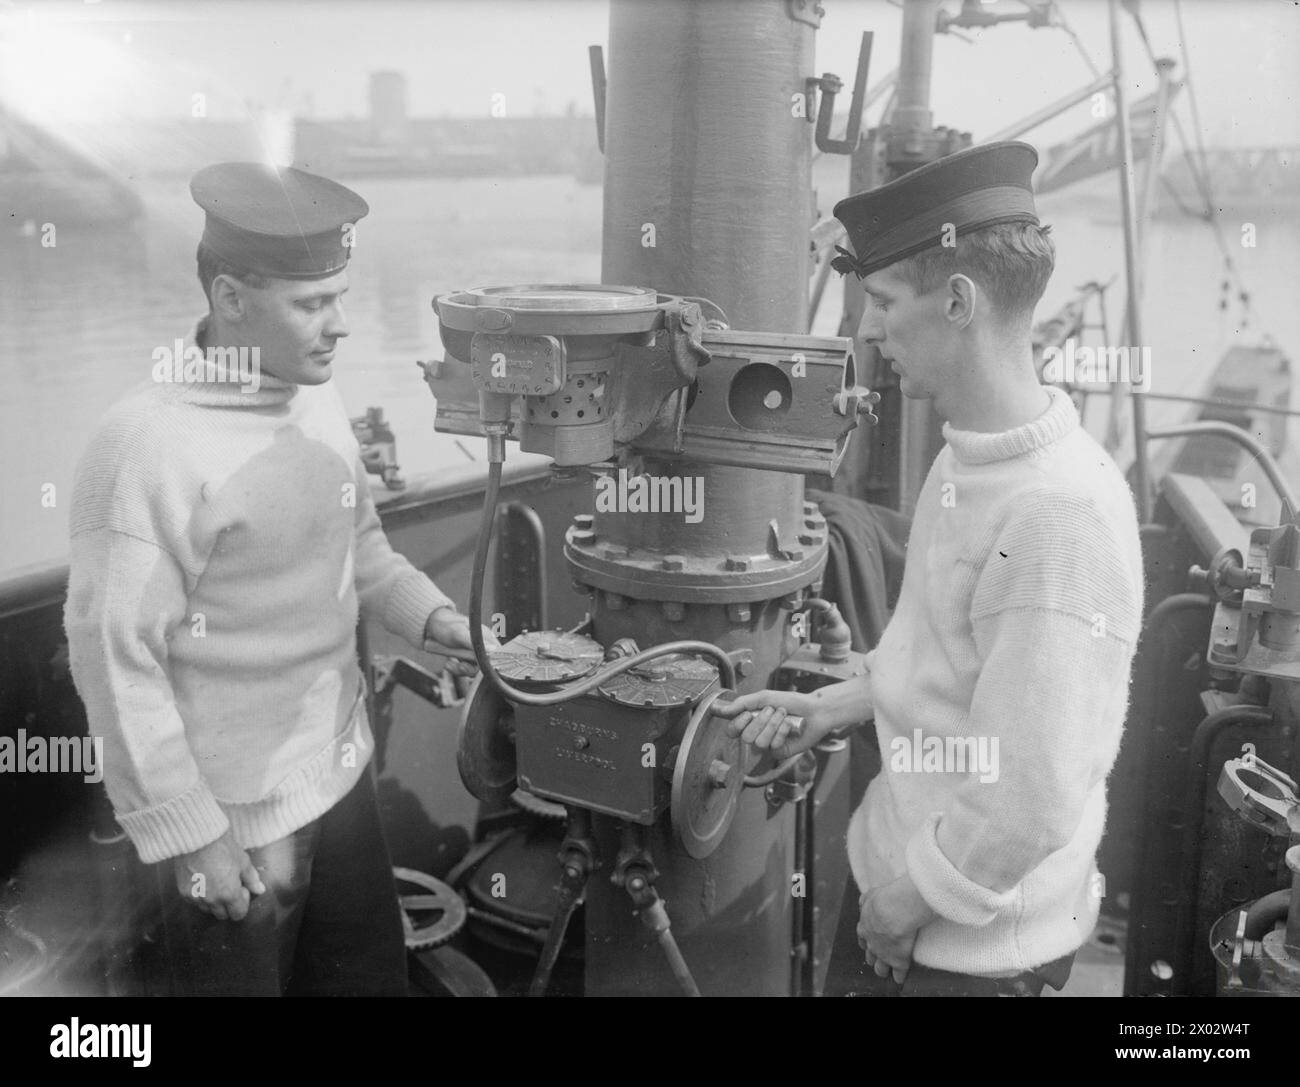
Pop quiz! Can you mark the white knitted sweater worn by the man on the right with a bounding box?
[849,387,1143,974]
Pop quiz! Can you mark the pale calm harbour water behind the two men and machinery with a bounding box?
[0,170,1300,571]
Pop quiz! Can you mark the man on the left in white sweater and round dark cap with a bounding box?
[65,164,495,995]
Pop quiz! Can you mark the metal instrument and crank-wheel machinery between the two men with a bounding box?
[425,285,876,995]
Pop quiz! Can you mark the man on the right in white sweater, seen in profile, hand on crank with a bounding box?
[729,143,1143,996]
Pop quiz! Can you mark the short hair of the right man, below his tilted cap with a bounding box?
[889,222,1056,317]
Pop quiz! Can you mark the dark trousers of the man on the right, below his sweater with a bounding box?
[824,879,1074,996]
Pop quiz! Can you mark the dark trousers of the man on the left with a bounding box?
[160,771,407,996]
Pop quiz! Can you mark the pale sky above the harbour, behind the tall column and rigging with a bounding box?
[0,0,1300,146]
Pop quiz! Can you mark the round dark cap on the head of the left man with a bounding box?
[190,163,371,280]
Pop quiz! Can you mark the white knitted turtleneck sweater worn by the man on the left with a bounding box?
[64,318,451,862]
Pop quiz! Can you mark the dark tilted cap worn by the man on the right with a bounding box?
[831,140,1039,278]
